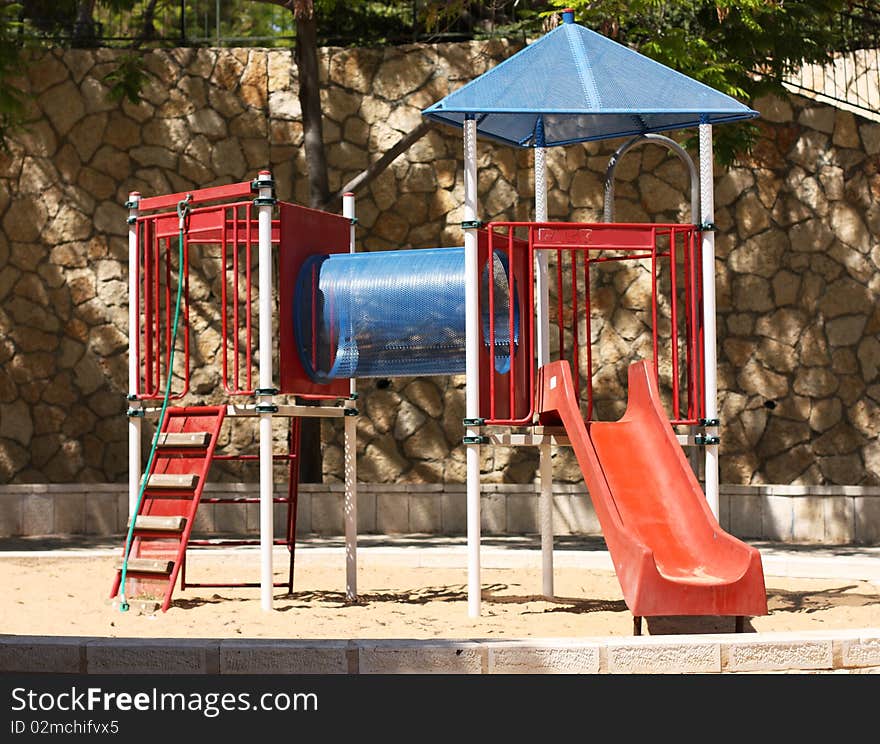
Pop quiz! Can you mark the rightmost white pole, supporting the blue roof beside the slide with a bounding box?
[700,123,719,519]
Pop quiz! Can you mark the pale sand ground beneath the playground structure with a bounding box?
[0,550,880,639]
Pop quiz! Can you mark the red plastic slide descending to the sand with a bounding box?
[538,361,767,616]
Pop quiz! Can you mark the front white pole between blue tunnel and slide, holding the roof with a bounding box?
[464,116,481,617]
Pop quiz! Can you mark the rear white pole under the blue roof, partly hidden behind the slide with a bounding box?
[535,120,552,599]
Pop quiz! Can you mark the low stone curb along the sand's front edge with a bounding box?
[0,628,880,674]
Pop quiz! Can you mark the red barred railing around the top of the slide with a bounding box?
[483,222,705,425]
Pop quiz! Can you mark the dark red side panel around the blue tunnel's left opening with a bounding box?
[278,202,351,398]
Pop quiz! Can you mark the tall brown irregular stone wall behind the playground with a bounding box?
[0,41,880,485]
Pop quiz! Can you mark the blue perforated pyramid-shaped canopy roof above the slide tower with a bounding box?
[422,11,758,147]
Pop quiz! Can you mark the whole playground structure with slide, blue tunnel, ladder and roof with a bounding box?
[111,11,767,632]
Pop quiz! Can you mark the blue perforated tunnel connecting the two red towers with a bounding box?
[294,247,519,382]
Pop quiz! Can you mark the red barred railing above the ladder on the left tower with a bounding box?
[133,192,279,400]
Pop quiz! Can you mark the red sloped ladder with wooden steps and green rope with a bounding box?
[110,406,226,612]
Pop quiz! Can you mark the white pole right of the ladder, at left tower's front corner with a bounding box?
[257,171,275,611]
